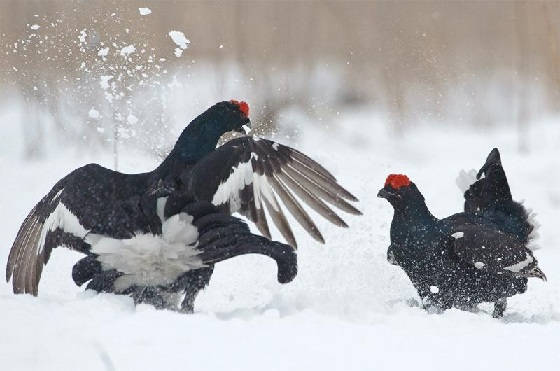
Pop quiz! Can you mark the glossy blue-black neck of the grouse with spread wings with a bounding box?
[155,116,223,178]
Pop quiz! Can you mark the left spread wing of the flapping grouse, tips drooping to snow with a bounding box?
[6,164,160,295]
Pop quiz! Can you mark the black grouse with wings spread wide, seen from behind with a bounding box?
[6,100,360,312]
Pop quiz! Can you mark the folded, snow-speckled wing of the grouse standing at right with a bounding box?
[445,214,546,280]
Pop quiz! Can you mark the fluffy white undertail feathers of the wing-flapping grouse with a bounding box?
[91,213,204,292]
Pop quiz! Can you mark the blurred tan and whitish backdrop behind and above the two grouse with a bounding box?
[0,0,560,158]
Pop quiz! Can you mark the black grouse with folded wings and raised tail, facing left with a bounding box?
[378,149,546,317]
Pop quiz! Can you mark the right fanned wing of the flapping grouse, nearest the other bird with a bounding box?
[184,137,361,248]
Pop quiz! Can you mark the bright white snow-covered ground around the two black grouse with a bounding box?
[0,106,560,371]
